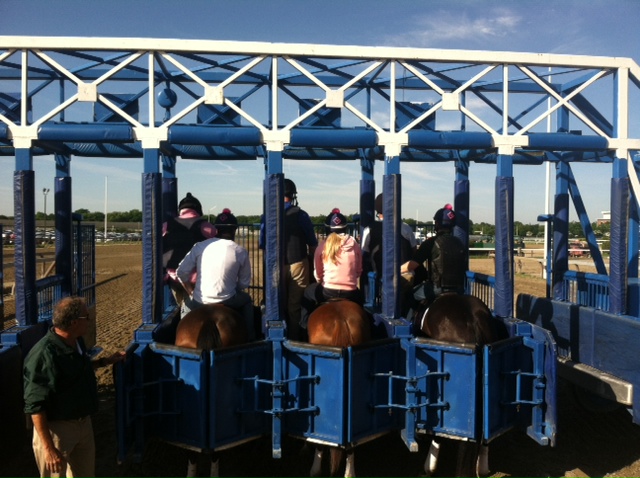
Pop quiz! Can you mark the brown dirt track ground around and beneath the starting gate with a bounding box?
[0,246,640,478]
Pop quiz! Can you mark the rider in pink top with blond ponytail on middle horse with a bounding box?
[300,208,363,329]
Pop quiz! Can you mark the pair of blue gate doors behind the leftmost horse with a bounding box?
[116,342,271,459]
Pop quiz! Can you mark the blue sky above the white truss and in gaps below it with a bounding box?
[0,0,640,223]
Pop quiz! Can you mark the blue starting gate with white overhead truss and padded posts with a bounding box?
[0,37,640,470]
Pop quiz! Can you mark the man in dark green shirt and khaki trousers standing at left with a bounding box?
[24,297,125,478]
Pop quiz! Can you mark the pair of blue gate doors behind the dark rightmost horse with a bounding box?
[403,319,556,446]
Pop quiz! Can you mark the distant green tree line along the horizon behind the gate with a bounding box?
[0,209,611,237]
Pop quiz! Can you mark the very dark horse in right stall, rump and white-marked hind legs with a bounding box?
[413,292,507,478]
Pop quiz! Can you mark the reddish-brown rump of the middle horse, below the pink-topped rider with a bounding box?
[307,300,371,347]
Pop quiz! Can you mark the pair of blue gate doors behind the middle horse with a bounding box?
[283,340,401,446]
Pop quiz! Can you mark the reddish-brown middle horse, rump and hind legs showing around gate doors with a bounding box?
[307,299,371,478]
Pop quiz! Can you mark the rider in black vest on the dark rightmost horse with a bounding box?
[401,204,467,317]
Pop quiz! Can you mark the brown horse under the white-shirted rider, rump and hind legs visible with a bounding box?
[175,304,249,478]
